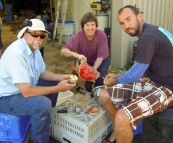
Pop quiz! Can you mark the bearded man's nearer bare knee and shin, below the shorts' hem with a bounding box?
[115,109,133,143]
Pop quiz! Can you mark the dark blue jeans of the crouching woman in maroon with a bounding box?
[85,58,110,92]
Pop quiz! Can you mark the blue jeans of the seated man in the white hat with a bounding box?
[0,80,58,143]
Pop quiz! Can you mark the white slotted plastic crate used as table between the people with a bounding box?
[50,94,112,143]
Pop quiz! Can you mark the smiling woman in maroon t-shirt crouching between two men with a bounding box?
[61,12,110,92]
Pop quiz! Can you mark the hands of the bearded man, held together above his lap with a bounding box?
[103,74,121,87]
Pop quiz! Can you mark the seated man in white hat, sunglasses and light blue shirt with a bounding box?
[0,19,75,143]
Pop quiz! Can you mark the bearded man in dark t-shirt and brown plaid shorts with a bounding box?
[99,5,173,143]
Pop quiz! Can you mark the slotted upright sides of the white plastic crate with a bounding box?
[51,109,110,143]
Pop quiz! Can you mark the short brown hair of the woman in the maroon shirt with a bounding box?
[81,12,98,29]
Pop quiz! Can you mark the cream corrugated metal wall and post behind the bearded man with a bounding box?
[111,0,173,68]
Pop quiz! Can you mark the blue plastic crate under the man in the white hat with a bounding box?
[0,114,31,143]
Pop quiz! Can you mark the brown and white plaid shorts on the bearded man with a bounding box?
[106,77,173,130]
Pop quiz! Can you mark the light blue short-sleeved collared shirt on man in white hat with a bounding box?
[0,38,46,97]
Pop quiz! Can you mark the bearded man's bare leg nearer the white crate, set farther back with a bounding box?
[99,90,118,142]
